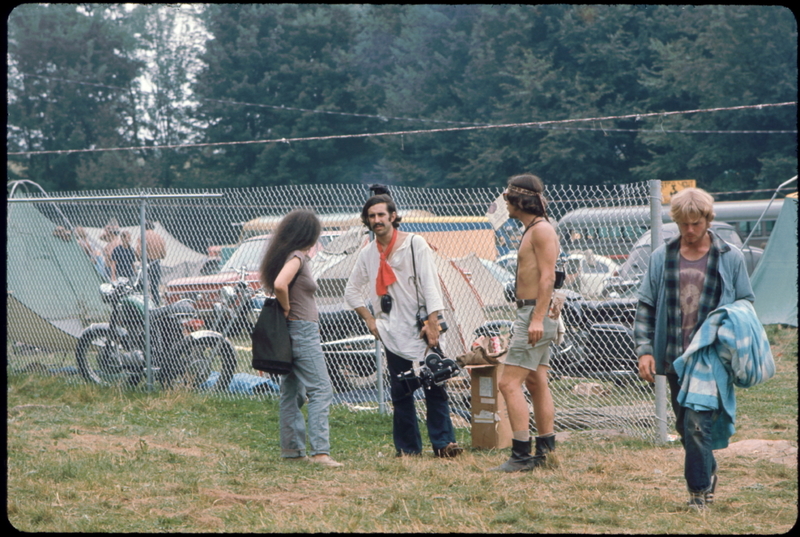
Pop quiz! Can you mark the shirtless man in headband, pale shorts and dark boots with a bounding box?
[491,174,559,472]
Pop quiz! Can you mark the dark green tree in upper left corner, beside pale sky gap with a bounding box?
[6,4,142,190]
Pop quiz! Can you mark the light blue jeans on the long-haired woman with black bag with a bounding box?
[280,321,333,458]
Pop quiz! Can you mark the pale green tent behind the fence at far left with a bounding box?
[6,196,108,350]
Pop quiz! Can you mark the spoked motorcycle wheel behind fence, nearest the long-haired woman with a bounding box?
[161,337,236,391]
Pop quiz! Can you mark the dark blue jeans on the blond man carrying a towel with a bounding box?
[667,374,717,492]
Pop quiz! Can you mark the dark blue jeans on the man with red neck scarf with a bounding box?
[384,347,456,454]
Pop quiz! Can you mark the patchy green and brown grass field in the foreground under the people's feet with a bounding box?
[7,328,798,534]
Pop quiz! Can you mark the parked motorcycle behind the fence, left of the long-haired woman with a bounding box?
[75,276,236,391]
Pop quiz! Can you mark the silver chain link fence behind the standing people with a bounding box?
[6,182,668,439]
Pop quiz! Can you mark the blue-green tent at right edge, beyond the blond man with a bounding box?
[750,193,797,326]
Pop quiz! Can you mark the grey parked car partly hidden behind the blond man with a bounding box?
[603,220,764,297]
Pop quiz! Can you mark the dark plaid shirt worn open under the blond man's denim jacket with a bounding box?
[634,231,729,373]
